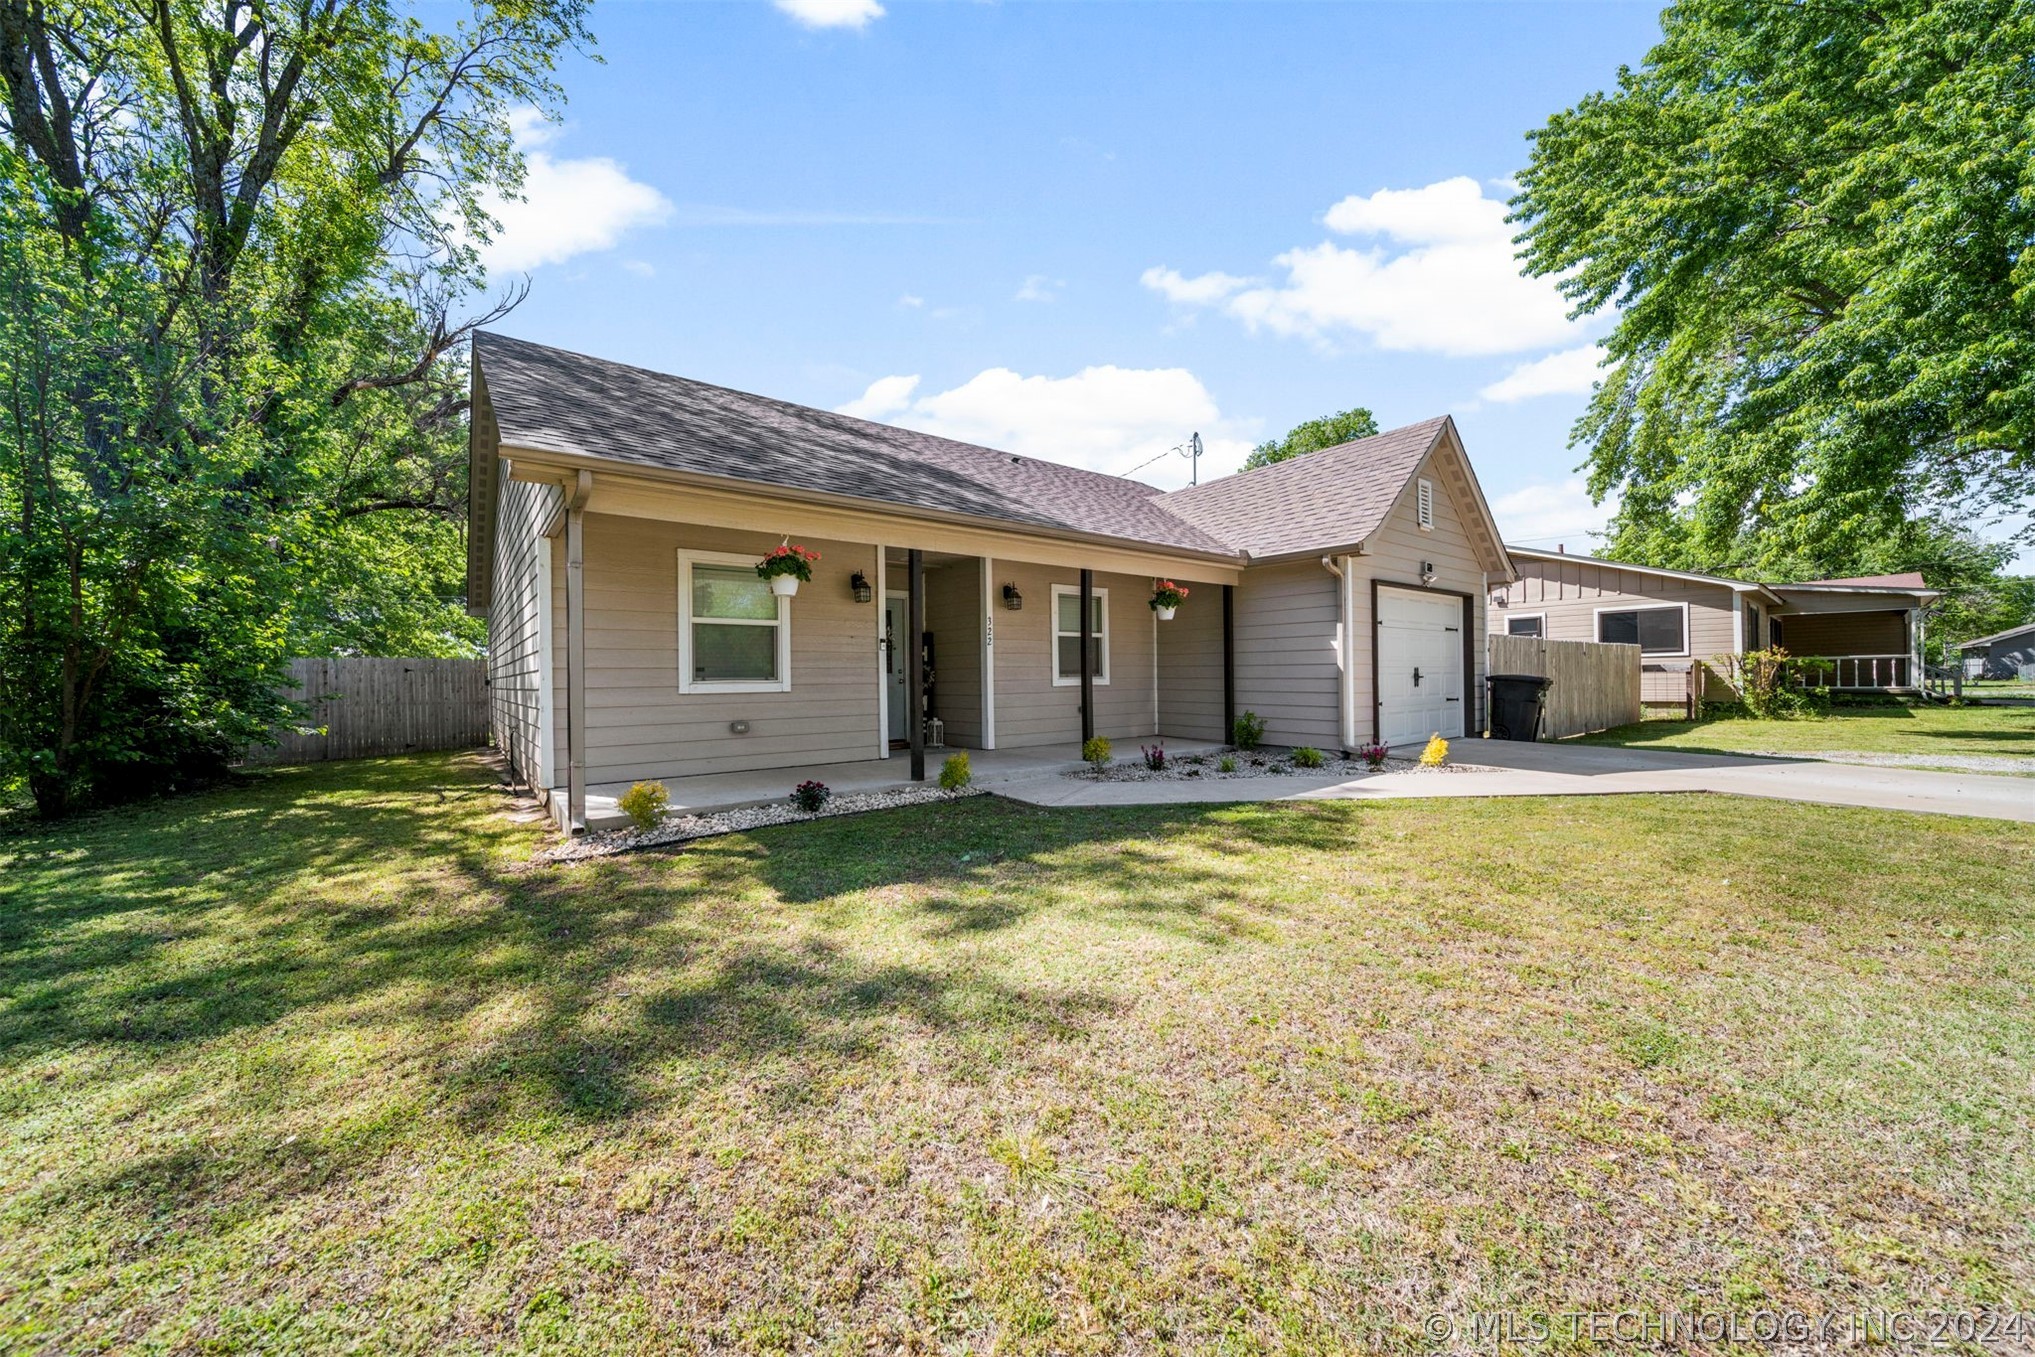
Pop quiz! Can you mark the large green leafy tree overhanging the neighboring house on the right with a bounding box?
[1512,0,2035,574]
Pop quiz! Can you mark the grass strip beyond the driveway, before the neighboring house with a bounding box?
[1575,704,2035,759]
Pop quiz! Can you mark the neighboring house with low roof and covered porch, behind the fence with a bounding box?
[1490,545,1941,702]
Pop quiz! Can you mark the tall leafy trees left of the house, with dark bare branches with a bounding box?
[0,0,590,814]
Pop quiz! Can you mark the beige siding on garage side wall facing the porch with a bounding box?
[1215,559,1343,749]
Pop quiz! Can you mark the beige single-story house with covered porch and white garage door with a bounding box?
[468,334,1512,824]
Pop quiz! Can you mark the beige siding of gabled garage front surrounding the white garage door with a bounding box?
[1349,454,1488,741]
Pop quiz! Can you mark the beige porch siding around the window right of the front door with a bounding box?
[993,562,1156,749]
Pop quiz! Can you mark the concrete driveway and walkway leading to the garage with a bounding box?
[997,741,2035,824]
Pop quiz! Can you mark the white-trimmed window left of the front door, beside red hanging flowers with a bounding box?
[678,551,792,692]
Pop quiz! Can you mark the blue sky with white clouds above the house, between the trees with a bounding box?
[476,0,1684,549]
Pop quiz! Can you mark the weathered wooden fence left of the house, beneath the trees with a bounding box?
[248,657,488,763]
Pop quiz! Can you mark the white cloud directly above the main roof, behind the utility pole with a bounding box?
[840,366,1252,486]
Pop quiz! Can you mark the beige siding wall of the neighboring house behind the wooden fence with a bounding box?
[1490,557,1738,690]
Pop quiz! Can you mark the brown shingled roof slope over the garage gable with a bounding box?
[1160,415,1449,557]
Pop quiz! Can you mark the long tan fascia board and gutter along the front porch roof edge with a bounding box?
[503,444,1245,584]
